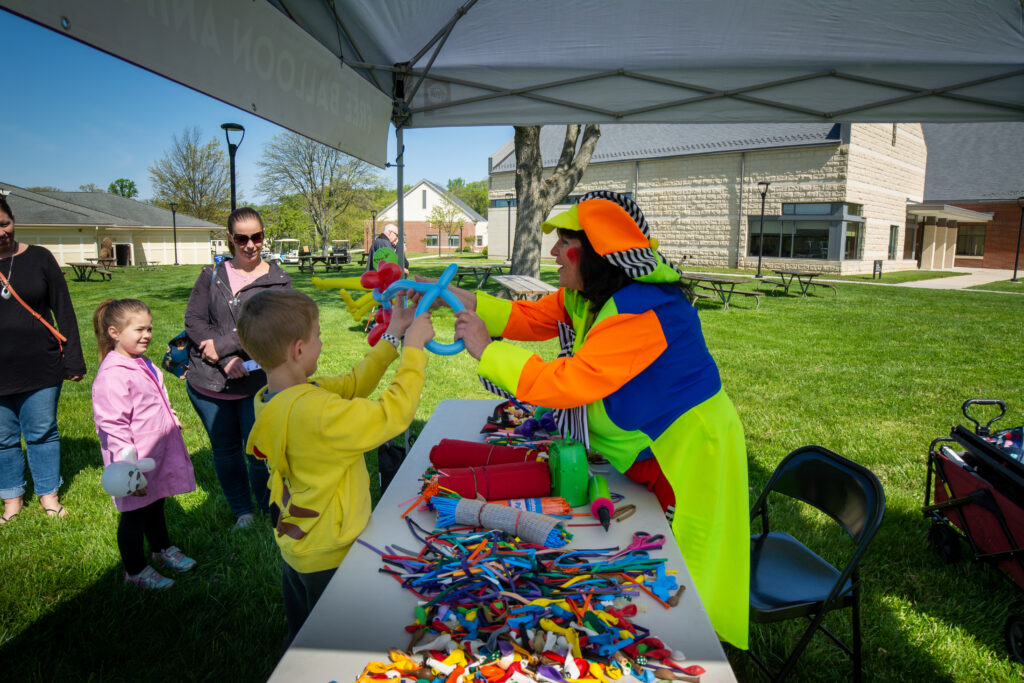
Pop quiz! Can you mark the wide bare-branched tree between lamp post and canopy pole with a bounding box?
[256,133,380,255]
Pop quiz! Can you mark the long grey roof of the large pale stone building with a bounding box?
[490,123,842,173]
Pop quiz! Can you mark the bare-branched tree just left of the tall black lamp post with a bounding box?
[150,126,231,224]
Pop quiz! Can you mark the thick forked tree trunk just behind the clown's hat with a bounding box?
[509,124,601,278]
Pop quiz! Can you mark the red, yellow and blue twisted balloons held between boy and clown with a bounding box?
[313,261,465,355]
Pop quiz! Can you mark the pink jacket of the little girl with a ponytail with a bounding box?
[92,351,196,512]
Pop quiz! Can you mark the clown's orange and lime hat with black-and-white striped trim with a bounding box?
[541,189,679,283]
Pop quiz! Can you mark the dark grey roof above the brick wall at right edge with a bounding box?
[922,123,1024,202]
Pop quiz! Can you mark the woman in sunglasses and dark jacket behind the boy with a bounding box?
[185,207,292,528]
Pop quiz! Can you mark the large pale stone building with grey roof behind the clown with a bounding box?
[488,123,927,273]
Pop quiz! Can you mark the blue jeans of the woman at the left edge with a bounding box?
[0,384,63,500]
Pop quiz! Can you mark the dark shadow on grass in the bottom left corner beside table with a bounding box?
[0,481,286,683]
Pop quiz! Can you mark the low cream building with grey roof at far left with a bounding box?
[0,182,224,265]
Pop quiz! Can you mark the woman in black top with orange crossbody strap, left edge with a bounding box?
[0,197,85,524]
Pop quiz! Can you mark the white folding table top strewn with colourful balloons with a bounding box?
[269,399,736,683]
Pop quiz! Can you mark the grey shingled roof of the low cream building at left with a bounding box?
[0,182,223,228]
